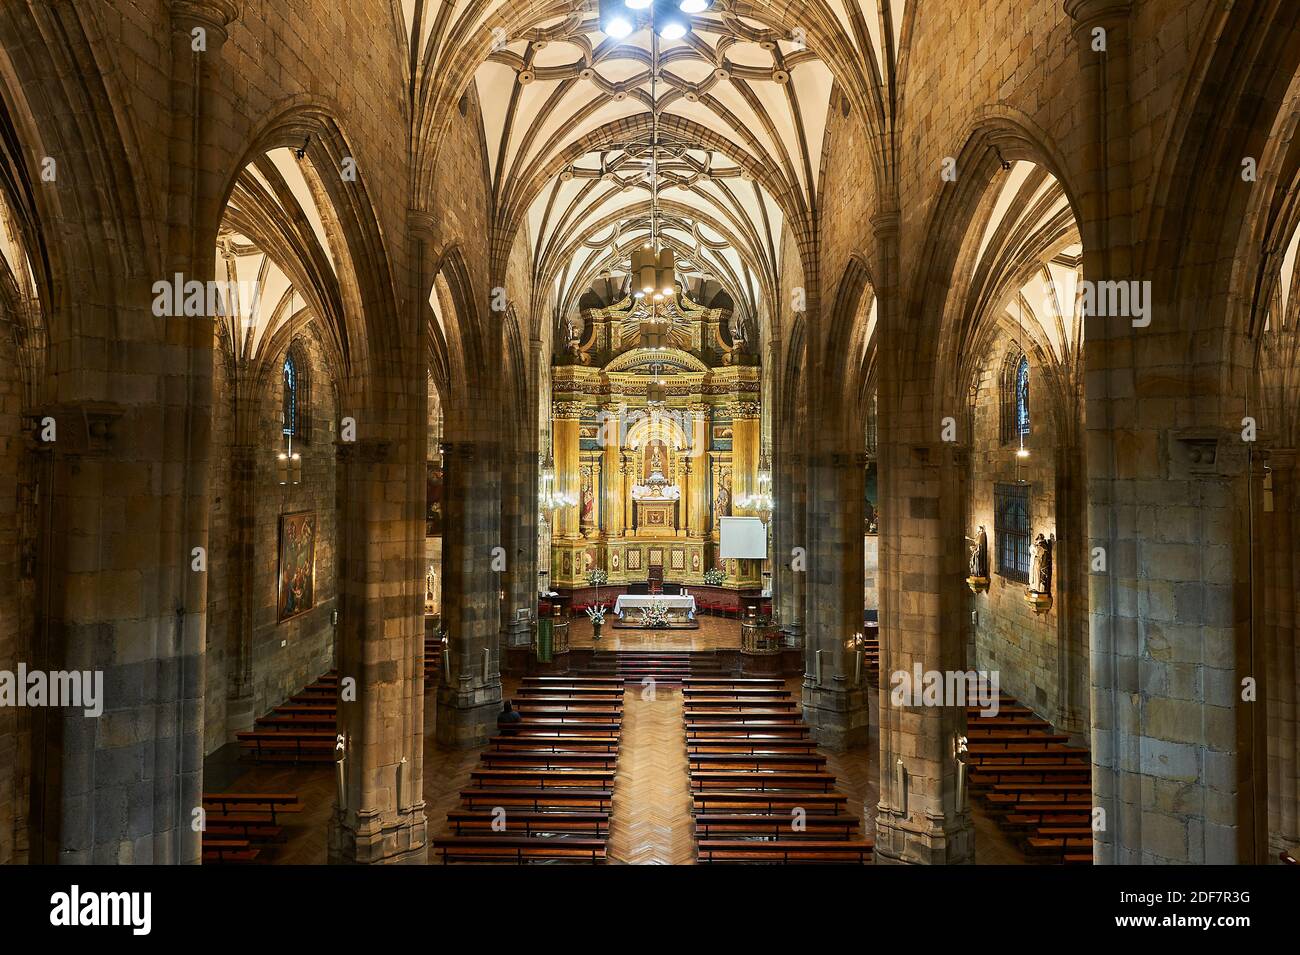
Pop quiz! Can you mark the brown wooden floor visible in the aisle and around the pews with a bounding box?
[204,654,1027,865]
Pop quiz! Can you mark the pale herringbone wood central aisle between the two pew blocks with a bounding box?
[607,685,696,865]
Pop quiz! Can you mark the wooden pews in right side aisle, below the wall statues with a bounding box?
[966,694,1092,864]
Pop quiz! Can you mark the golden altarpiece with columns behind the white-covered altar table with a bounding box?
[551,292,762,590]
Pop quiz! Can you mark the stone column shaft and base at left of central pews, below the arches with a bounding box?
[329,428,428,864]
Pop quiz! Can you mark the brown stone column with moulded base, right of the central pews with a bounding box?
[859,212,975,864]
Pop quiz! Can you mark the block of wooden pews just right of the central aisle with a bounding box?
[681,676,872,864]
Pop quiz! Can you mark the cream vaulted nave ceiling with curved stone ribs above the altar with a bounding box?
[402,0,905,340]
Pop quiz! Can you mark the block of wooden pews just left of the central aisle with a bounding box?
[433,676,624,863]
